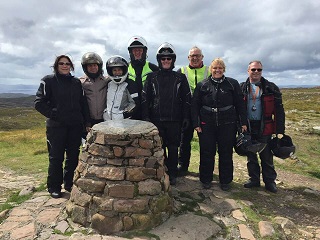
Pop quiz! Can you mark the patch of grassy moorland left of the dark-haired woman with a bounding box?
[0,108,48,175]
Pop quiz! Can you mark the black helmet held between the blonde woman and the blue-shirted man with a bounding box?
[234,132,267,156]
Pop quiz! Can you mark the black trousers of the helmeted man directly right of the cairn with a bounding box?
[153,121,181,178]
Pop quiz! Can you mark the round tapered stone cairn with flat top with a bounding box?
[67,119,173,234]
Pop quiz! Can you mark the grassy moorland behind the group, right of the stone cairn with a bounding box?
[190,88,320,179]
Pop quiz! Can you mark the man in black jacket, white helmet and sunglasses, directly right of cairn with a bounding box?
[141,43,191,185]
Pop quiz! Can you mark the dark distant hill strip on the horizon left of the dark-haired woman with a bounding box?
[0,93,36,108]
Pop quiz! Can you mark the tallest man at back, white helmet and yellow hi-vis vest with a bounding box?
[128,36,159,119]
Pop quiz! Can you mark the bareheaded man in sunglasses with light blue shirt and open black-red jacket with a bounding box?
[241,60,285,193]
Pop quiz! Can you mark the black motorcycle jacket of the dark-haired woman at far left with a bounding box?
[35,73,90,127]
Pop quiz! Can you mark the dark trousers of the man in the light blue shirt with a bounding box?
[247,121,277,184]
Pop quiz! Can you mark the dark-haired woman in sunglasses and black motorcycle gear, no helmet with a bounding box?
[35,55,90,198]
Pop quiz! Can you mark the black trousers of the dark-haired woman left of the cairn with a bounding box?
[46,124,83,192]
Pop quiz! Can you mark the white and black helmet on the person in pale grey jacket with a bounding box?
[106,56,128,84]
